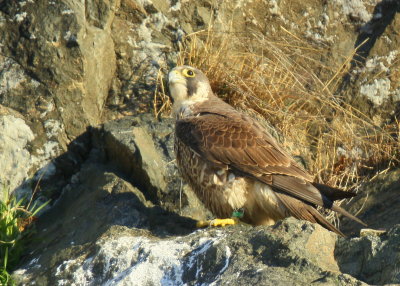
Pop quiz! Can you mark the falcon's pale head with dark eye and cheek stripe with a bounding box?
[168,66,213,116]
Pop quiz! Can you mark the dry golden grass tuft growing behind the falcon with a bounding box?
[154,22,399,192]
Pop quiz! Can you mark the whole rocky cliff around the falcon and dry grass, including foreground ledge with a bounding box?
[0,0,400,285]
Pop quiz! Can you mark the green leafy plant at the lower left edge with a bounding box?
[0,187,49,285]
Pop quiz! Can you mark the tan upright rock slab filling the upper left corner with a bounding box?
[0,1,119,199]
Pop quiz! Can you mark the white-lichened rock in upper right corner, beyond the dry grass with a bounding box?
[341,0,400,120]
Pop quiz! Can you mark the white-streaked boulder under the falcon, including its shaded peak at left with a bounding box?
[14,172,368,285]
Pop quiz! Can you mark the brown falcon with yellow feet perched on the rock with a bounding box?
[168,66,364,236]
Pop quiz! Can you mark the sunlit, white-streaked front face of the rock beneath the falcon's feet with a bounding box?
[15,222,370,285]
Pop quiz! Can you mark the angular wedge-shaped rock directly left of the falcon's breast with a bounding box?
[92,114,210,219]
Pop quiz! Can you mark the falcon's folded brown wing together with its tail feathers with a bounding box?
[175,108,364,230]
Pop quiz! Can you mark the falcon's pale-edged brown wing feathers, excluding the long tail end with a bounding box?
[176,111,312,181]
